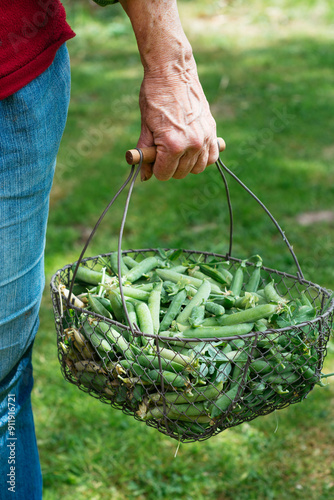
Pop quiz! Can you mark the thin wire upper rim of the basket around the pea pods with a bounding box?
[50,248,334,344]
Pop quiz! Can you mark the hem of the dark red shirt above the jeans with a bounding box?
[0,0,75,99]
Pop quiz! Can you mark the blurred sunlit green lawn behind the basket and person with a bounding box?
[33,0,334,500]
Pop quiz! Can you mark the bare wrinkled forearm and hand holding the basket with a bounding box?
[120,0,218,180]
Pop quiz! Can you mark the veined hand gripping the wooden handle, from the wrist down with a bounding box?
[137,58,219,181]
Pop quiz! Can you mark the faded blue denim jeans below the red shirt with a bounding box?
[0,45,70,500]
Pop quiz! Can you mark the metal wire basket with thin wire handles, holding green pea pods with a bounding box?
[51,150,334,442]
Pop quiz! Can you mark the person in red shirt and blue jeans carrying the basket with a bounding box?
[0,0,218,500]
